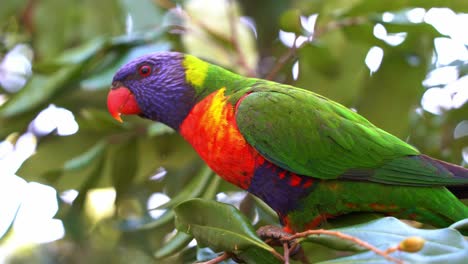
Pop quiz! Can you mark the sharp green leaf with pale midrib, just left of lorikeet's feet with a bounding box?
[174,199,273,254]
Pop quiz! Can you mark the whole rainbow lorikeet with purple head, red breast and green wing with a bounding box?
[107,52,468,232]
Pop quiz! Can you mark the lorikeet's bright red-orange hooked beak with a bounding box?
[107,86,141,123]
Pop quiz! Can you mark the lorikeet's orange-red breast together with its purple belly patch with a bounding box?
[179,89,315,219]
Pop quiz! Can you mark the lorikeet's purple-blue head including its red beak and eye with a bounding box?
[107,52,196,130]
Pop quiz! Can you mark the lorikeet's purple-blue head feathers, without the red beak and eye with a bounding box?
[112,52,195,130]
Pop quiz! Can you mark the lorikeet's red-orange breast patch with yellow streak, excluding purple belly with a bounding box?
[179,88,264,189]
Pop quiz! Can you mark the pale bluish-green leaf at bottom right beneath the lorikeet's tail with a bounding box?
[305,217,468,263]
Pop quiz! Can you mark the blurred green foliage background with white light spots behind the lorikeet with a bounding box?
[0,0,468,263]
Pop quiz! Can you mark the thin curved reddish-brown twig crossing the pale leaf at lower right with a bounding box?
[284,229,403,264]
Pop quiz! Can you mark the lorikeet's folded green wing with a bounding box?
[238,80,468,186]
